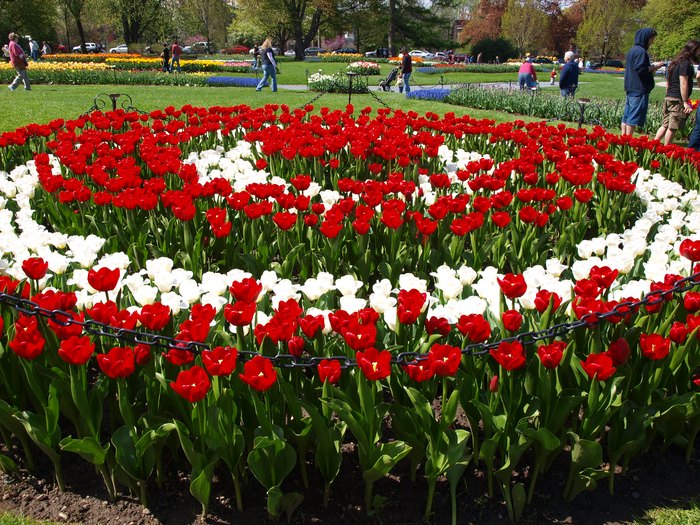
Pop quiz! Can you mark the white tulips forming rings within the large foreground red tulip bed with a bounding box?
[0,142,700,340]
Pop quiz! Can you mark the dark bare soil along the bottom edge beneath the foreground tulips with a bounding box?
[0,438,700,525]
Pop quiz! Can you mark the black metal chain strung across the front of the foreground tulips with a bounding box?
[0,272,700,369]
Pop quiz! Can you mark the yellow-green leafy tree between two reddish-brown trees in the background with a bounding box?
[501,0,548,56]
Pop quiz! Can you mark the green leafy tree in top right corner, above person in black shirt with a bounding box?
[642,0,700,58]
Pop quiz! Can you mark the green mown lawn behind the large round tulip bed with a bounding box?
[0,56,664,131]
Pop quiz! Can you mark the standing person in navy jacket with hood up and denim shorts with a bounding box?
[622,27,664,135]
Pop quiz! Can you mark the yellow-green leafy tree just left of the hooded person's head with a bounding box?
[576,0,638,61]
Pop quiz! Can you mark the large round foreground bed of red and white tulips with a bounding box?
[0,105,700,522]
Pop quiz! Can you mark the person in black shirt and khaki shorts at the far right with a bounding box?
[654,40,700,146]
